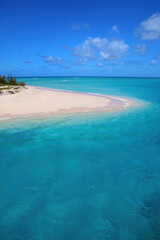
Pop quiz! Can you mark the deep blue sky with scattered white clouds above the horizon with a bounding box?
[0,0,160,77]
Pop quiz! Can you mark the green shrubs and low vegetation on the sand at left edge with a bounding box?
[0,75,25,95]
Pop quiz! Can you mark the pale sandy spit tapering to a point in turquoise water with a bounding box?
[0,86,137,121]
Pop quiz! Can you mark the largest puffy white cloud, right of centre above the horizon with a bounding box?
[71,37,129,65]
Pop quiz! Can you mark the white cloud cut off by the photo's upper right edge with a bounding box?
[136,13,160,40]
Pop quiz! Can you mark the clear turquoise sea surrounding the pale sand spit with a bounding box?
[0,77,160,240]
